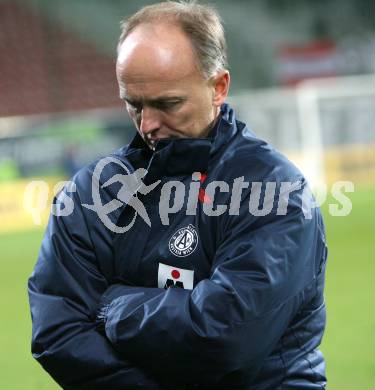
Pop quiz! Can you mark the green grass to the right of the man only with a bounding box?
[322,187,375,390]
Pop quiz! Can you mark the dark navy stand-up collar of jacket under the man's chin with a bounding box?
[122,103,237,177]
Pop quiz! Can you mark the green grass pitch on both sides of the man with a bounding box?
[0,187,375,390]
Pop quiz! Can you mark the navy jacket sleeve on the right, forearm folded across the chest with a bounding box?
[98,183,325,384]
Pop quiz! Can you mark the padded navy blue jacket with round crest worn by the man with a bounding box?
[29,105,327,389]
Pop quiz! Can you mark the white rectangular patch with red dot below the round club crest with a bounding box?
[158,263,194,290]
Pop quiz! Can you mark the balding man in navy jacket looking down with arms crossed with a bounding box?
[29,2,326,389]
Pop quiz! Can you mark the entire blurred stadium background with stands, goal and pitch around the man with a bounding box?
[0,0,375,390]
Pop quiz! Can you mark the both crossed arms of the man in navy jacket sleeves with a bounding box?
[29,179,322,389]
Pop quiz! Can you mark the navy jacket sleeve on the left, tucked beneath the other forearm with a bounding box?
[28,184,160,389]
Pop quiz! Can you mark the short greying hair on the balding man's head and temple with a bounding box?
[118,1,228,78]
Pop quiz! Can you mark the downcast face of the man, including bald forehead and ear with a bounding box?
[116,24,229,148]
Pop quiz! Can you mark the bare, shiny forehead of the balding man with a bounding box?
[116,23,199,88]
